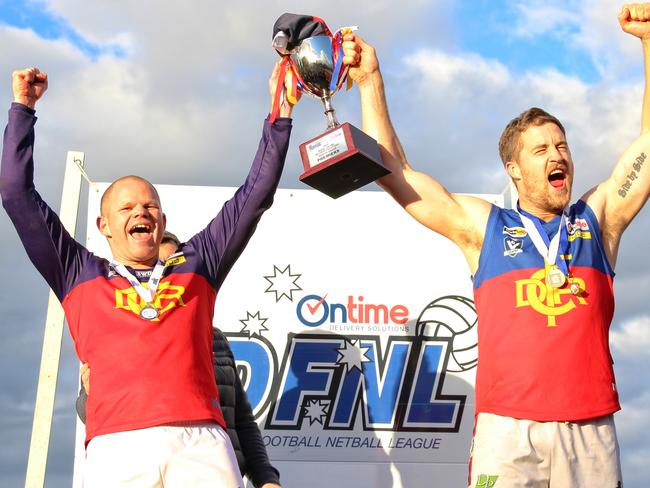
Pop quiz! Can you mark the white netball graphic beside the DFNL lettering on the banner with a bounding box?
[415,295,478,373]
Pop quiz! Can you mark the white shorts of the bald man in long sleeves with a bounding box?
[83,422,244,488]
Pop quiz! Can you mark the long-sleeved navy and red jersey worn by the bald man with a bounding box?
[0,104,291,442]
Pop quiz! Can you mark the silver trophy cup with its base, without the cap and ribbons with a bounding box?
[290,35,390,198]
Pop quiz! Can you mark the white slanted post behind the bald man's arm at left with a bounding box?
[25,151,84,488]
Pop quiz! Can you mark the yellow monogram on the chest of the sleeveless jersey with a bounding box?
[515,269,587,327]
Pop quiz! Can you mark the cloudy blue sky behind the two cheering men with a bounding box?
[0,0,650,488]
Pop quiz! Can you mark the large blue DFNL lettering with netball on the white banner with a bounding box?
[226,296,478,432]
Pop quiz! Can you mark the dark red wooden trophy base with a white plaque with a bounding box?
[300,122,390,198]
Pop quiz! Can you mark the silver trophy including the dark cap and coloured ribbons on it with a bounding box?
[271,13,390,198]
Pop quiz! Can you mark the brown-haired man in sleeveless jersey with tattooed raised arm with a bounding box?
[344,5,650,488]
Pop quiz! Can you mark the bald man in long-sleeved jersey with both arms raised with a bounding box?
[0,65,292,488]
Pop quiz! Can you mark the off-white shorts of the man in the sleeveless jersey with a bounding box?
[469,413,623,488]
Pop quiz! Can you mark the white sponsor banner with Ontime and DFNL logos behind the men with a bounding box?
[77,185,503,488]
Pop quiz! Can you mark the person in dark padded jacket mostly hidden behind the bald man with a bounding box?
[76,231,280,488]
